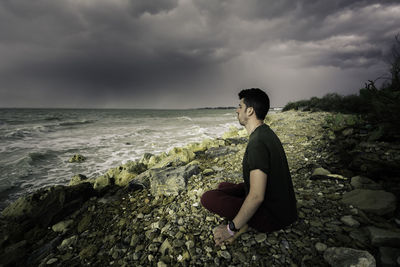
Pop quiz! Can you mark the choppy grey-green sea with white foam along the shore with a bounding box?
[0,108,241,210]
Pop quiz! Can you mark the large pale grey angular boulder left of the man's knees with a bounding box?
[148,165,200,196]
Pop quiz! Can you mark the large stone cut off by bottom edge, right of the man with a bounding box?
[324,247,376,267]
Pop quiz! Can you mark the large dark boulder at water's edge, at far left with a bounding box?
[2,183,95,227]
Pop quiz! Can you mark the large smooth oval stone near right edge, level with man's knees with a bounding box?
[341,189,396,215]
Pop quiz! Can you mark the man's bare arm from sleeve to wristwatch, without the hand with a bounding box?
[233,169,267,229]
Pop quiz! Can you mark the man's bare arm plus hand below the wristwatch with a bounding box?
[214,169,267,246]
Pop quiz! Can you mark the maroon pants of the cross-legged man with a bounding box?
[201,182,280,232]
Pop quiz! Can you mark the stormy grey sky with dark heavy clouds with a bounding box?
[0,0,400,108]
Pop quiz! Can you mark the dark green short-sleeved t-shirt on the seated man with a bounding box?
[243,124,297,226]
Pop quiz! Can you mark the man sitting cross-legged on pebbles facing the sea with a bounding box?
[201,88,297,245]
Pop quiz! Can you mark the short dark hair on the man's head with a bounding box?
[239,88,269,120]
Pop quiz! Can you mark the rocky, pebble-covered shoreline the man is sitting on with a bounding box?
[0,111,400,266]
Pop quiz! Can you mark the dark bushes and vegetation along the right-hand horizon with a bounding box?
[283,35,400,141]
